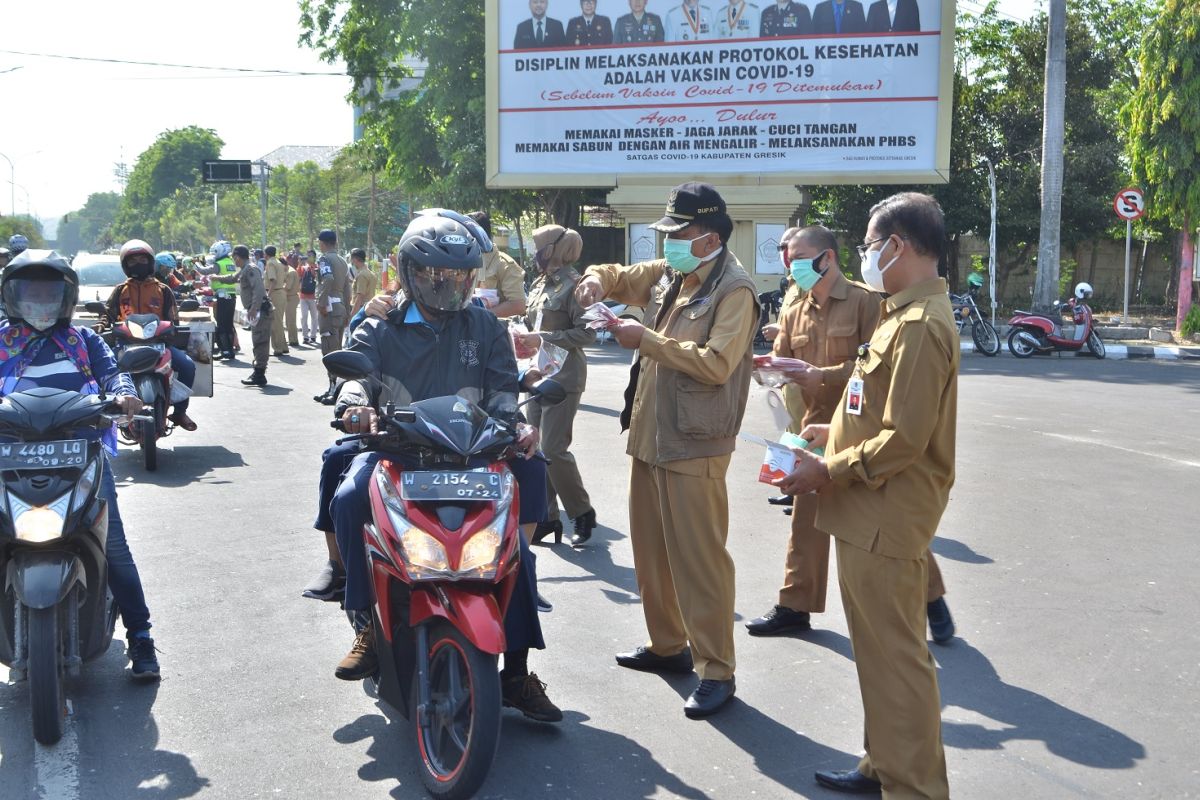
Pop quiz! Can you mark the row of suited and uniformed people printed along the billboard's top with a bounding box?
[512,0,920,50]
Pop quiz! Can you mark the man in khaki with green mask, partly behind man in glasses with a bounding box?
[746,225,954,642]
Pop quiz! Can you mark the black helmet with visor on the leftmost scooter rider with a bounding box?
[0,249,79,331]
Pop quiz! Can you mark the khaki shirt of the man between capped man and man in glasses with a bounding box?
[774,267,880,429]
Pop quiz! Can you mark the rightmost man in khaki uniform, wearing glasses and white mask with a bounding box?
[779,192,959,799]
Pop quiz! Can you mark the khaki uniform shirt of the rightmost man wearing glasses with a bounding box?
[816,278,959,560]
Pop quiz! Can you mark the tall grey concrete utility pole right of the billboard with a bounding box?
[1033,0,1067,312]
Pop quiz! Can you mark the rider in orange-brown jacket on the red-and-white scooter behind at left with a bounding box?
[104,239,196,431]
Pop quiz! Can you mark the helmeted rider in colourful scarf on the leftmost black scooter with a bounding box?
[0,249,158,681]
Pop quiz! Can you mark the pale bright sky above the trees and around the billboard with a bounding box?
[0,0,1043,225]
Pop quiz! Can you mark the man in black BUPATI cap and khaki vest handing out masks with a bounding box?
[576,184,758,718]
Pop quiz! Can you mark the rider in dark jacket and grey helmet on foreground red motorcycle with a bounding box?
[331,209,563,722]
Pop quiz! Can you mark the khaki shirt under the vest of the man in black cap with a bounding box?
[587,253,758,477]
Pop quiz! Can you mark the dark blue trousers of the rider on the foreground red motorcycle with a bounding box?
[330,449,546,650]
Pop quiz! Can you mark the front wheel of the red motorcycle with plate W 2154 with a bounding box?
[412,620,500,800]
